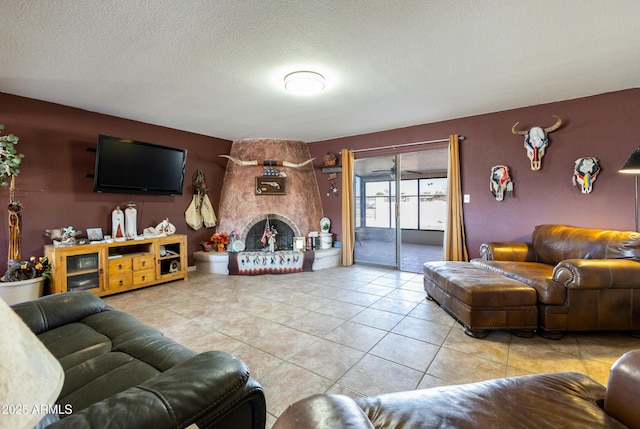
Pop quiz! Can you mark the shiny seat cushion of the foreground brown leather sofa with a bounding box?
[355,373,624,429]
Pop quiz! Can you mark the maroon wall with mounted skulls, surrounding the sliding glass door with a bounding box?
[309,89,640,257]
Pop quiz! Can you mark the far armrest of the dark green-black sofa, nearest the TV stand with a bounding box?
[11,291,108,335]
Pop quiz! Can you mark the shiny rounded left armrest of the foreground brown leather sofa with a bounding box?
[272,394,374,429]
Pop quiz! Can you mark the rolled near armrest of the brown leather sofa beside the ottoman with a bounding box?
[553,259,640,289]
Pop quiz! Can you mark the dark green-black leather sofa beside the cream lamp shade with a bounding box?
[12,292,266,429]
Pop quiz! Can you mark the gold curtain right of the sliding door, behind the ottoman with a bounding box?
[444,134,469,261]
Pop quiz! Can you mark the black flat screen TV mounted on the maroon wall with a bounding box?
[93,134,187,195]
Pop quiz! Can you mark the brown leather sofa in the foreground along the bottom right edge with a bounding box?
[273,350,640,429]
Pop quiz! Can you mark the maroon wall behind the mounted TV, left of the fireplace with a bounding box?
[0,94,231,266]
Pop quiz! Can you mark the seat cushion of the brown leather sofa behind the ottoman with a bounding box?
[471,259,567,305]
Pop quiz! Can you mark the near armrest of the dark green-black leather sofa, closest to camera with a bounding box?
[48,351,266,429]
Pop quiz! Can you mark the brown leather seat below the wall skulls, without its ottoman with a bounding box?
[471,225,640,337]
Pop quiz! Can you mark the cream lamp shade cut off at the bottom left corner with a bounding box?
[0,299,64,429]
